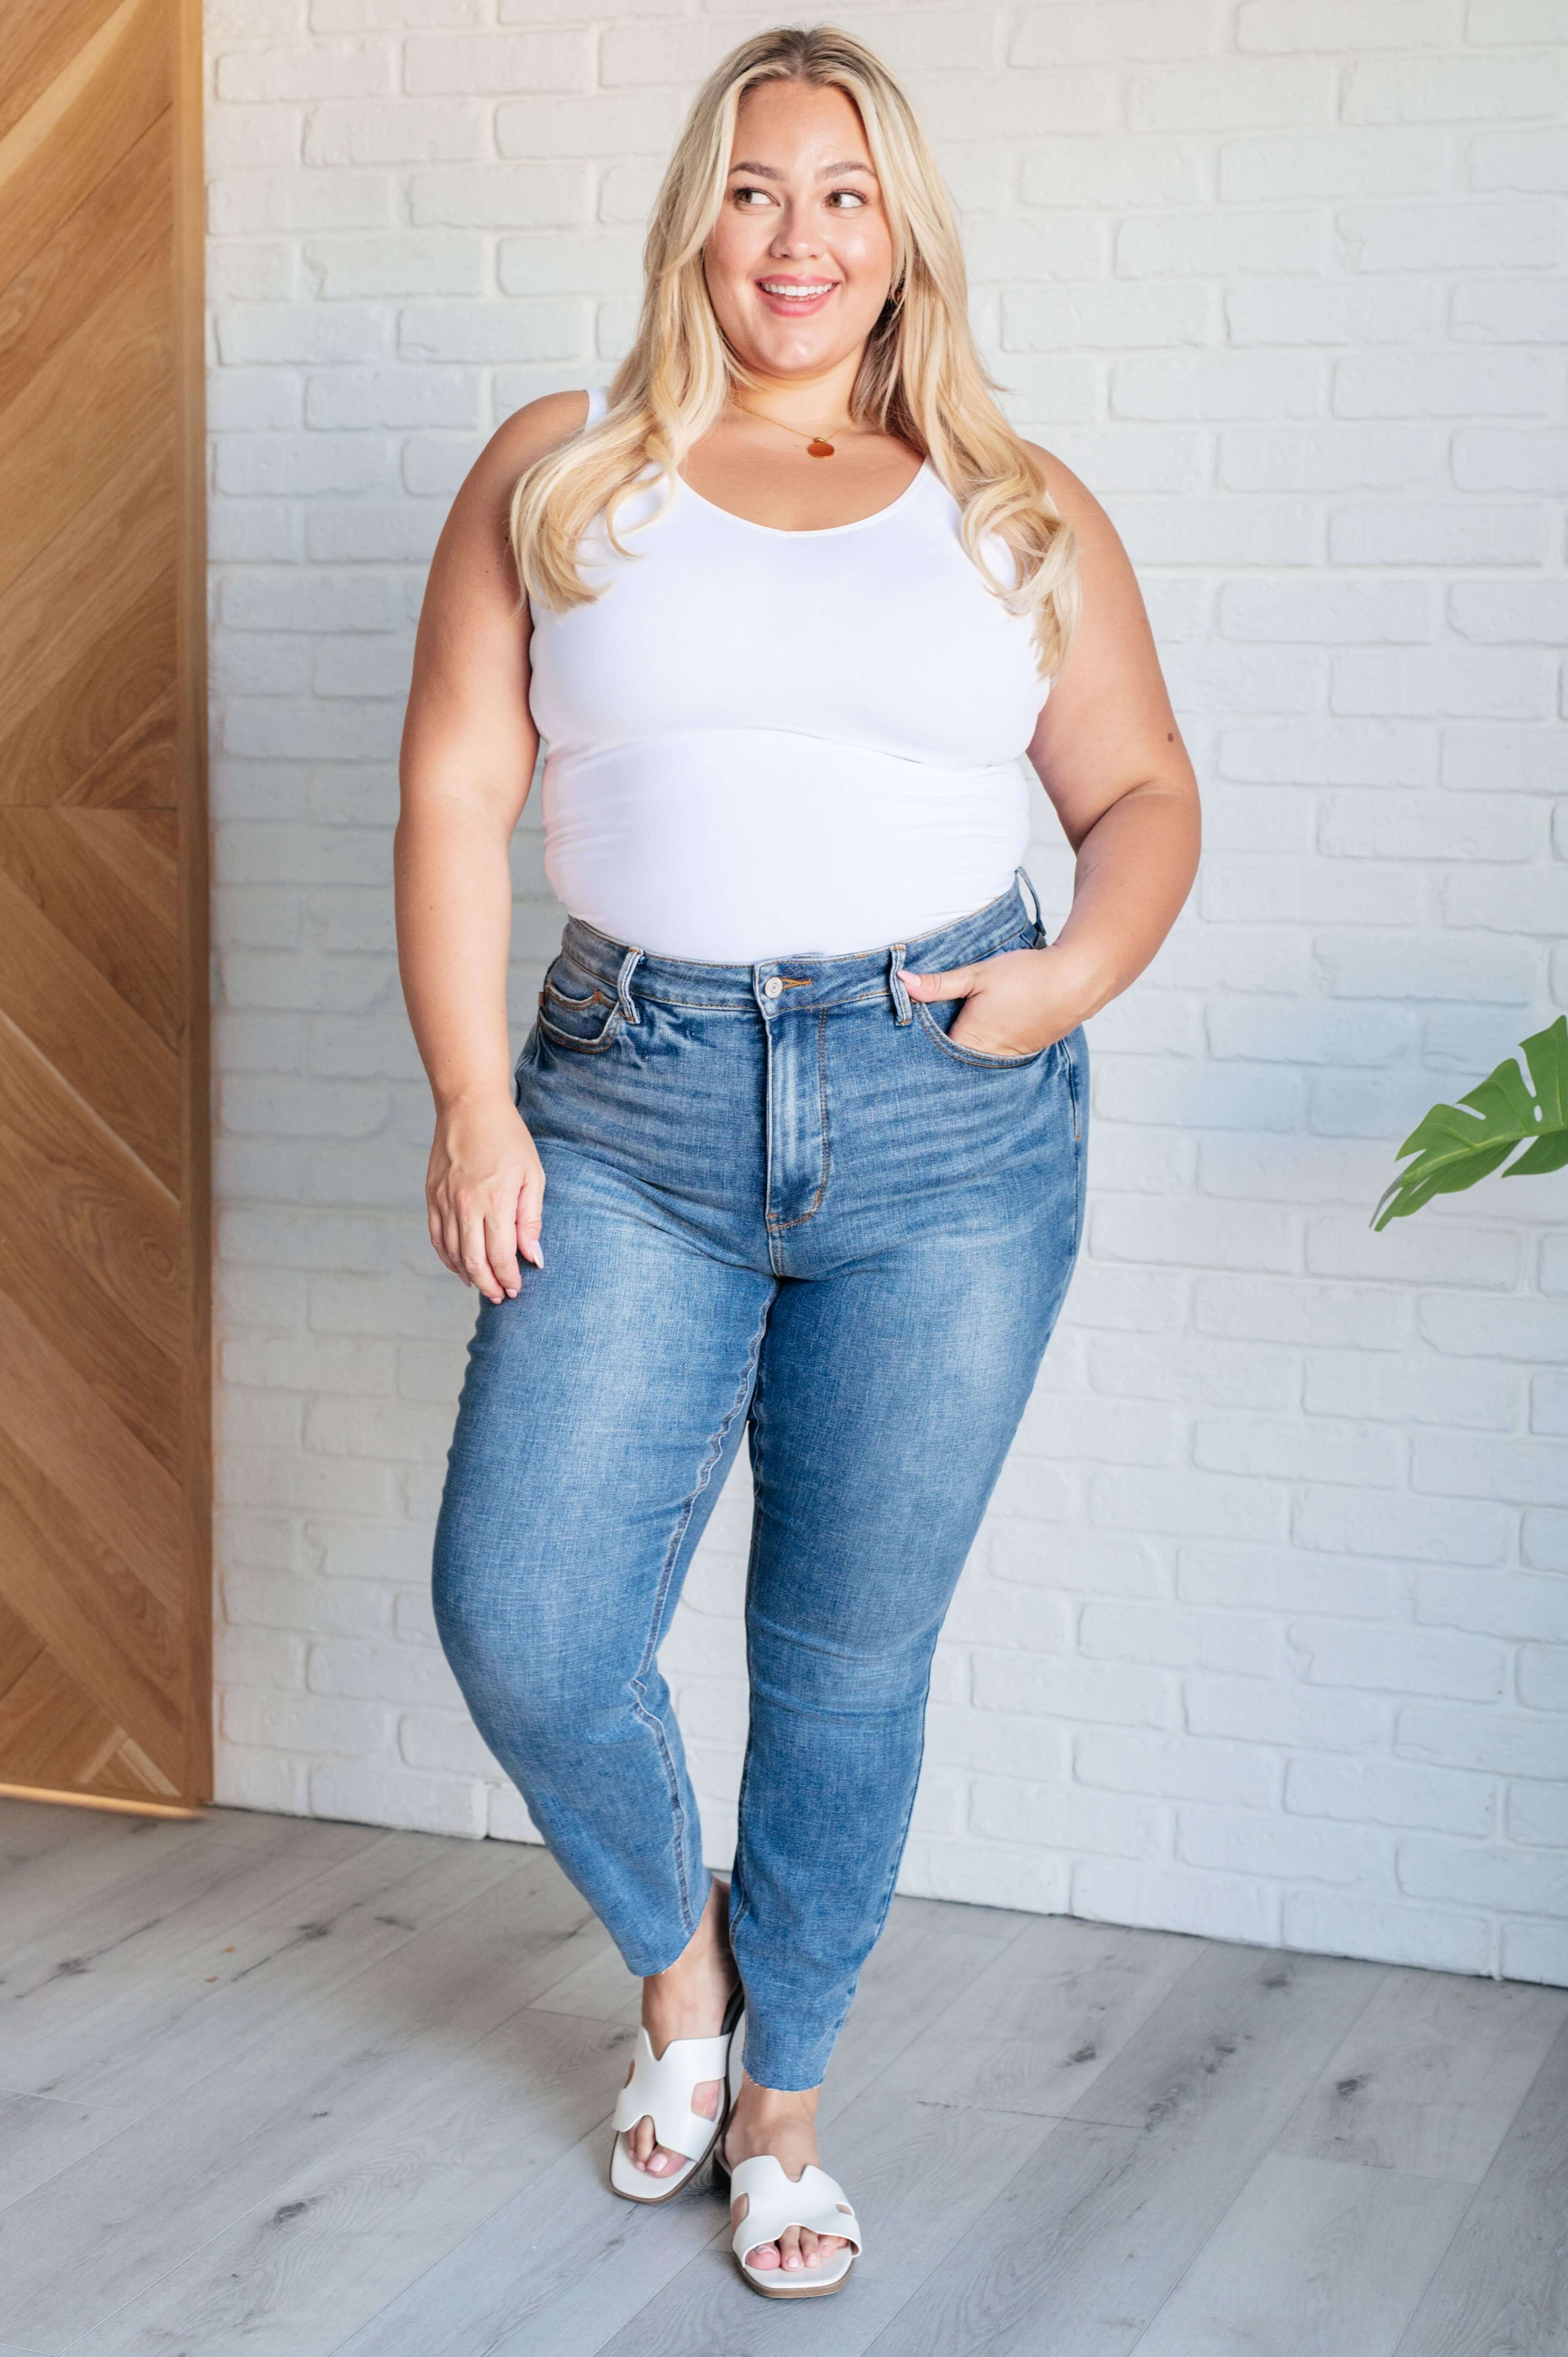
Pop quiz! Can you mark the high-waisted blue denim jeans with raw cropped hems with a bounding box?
[434,870,1087,2088]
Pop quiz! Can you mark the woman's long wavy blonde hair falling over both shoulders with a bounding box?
[509,26,1080,676]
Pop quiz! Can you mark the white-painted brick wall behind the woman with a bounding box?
[208,0,1568,1982]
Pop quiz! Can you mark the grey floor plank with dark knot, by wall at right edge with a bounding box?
[1278,1970,1568,2185]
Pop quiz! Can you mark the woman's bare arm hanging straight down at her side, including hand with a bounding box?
[394,393,587,1301]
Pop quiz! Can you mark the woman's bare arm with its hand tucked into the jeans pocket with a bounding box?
[912,450,1198,1056]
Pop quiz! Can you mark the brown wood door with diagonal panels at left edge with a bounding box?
[0,0,212,1808]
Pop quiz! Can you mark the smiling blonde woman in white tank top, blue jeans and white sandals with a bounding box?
[396,28,1198,2298]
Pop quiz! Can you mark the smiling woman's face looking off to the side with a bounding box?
[703,83,894,380]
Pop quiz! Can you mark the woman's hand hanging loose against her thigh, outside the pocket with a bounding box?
[424,1094,545,1301]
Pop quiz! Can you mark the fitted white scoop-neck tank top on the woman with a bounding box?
[531,393,1047,964]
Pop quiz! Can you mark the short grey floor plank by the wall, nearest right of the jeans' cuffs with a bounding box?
[887,1916,1203,2119]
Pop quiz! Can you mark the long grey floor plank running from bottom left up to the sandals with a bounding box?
[61,2006,646,2357]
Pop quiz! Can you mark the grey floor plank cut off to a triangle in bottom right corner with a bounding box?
[1396,2027,1568,2357]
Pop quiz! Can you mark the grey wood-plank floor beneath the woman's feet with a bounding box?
[0,1801,1568,2357]
